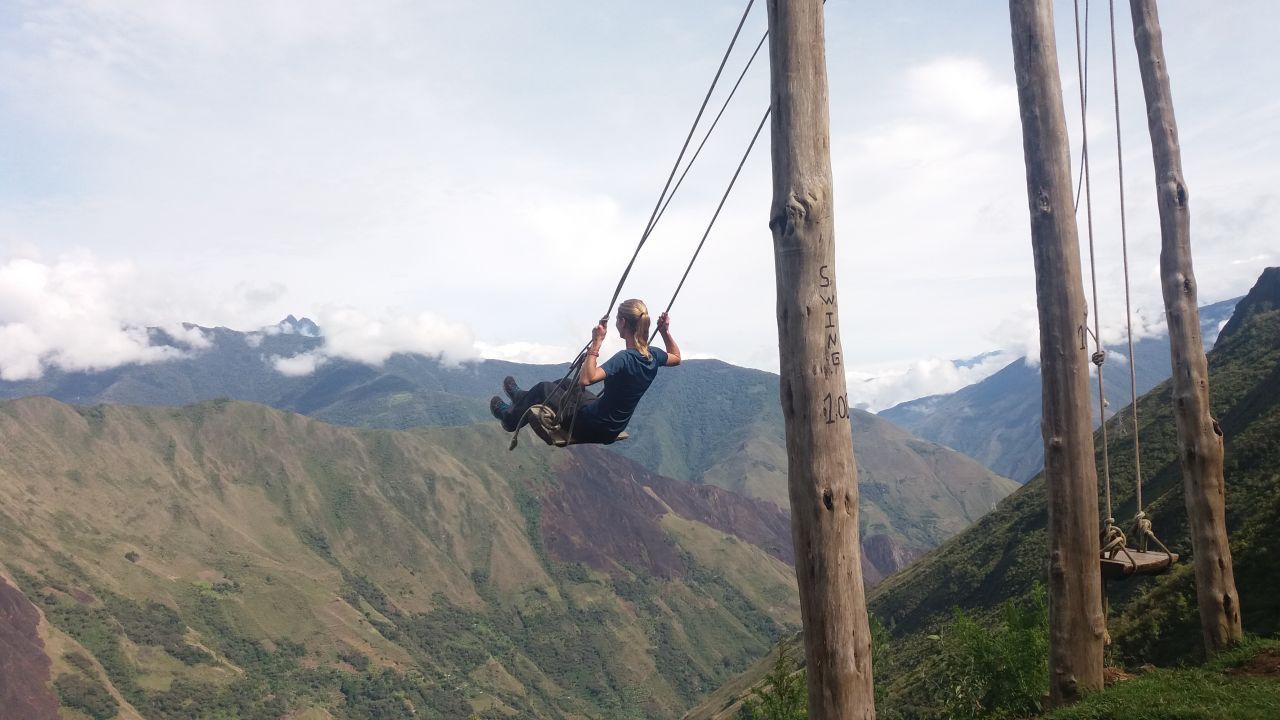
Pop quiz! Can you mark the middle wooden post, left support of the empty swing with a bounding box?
[1009,0,1105,705]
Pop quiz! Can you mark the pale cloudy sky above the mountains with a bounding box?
[0,0,1280,410]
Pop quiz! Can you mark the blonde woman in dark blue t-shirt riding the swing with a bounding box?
[489,300,680,443]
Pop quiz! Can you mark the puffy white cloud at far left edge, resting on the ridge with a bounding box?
[0,254,209,380]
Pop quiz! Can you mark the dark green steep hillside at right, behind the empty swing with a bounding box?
[686,268,1280,720]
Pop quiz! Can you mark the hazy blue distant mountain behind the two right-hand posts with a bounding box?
[879,297,1240,482]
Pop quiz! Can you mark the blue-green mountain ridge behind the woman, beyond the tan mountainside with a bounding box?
[0,330,1018,582]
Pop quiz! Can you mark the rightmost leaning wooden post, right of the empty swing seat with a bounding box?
[1129,0,1243,655]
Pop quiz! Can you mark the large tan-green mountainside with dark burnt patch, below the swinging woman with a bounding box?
[0,398,799,720]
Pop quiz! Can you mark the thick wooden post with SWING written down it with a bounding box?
[768,0,876,720]
